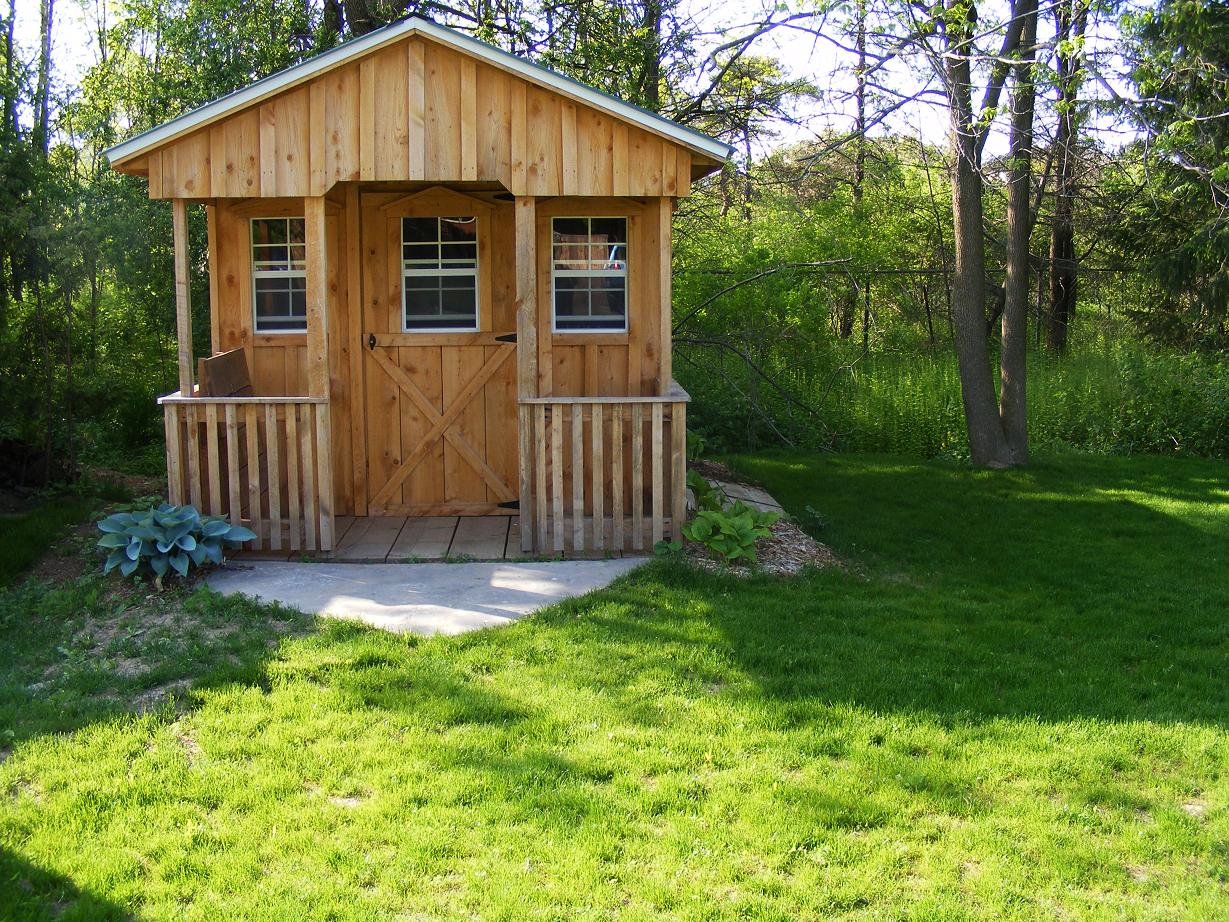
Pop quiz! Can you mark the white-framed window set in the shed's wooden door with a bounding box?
[401,216,478,333]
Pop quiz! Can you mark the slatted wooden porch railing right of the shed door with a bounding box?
[519,382,691,553]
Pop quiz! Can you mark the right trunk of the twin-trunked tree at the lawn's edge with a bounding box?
[999,0,1037,465]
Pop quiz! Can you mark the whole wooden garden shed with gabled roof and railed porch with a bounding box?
[108,17,730,554]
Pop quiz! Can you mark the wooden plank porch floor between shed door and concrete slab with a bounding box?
[236,515,651,563]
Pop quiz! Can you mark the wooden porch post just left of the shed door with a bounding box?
[304,195,333,551]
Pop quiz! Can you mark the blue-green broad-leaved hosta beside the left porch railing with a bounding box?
[98,503,256,585]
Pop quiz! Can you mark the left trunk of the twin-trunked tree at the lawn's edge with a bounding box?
[945,6,1011,467]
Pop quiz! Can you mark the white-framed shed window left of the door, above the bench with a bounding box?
[252,218,307,333]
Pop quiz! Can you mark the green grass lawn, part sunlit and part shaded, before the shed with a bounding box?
[0,455,1229,920]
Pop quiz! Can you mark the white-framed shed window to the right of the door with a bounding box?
[551,218,627,333]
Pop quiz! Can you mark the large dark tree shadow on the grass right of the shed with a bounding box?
[567,456,1229,727]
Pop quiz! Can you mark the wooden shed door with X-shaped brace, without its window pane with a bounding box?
[360,189,517,515]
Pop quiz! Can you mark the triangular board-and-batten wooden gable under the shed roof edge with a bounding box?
[134,36,710,199]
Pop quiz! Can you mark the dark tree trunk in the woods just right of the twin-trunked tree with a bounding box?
[1046,0,1088,352]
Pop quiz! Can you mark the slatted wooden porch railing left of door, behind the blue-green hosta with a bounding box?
[159,391,333,551]
